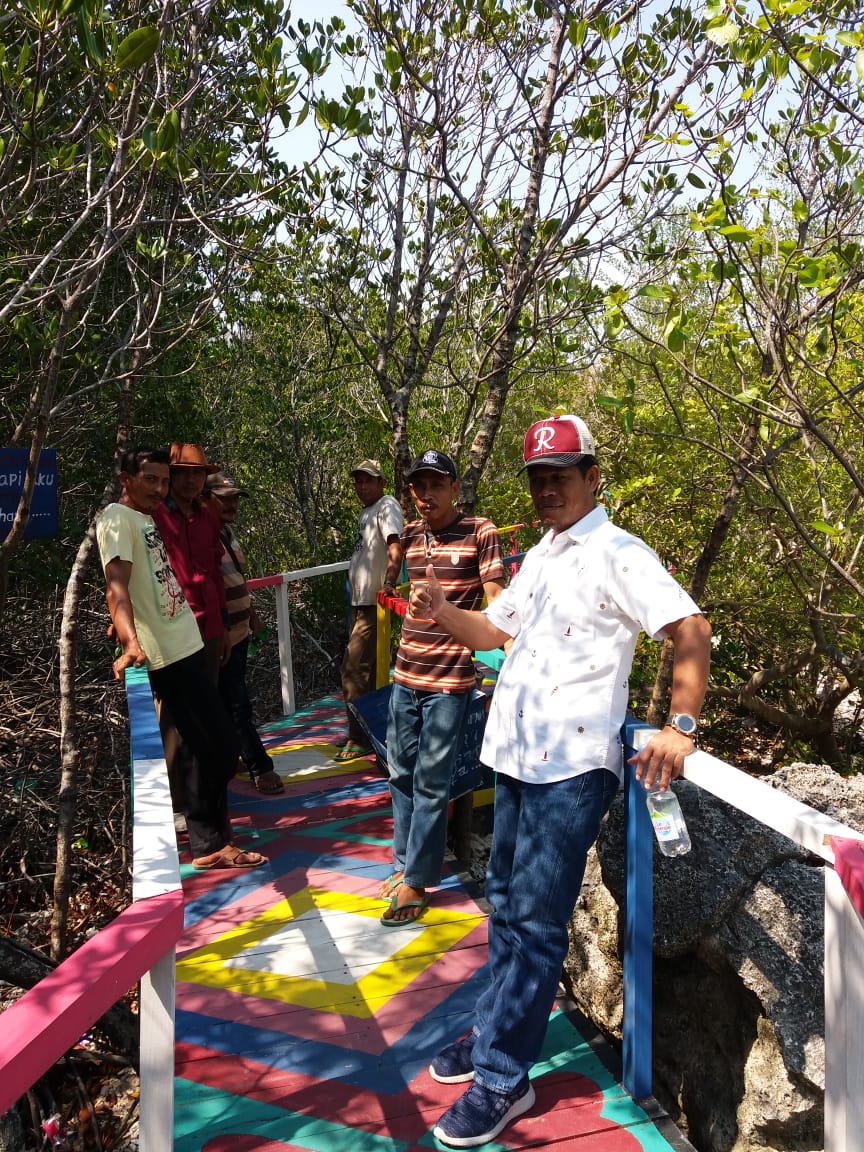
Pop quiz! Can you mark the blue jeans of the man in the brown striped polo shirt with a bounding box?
[387,684,471,888]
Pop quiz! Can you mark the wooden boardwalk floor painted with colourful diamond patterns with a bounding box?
[174,699,688,1152]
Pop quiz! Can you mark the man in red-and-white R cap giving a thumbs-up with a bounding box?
[411,415,711,1147]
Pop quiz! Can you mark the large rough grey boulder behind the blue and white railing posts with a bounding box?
[567,764,864,1152]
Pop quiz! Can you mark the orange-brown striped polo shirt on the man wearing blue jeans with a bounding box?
[394,515,503,692]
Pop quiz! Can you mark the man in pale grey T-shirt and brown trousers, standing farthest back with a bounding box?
[334,460,402,763]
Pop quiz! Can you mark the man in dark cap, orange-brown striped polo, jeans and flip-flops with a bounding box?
[381,448,505,927]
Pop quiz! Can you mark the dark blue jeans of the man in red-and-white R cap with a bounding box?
[473,768,619,1092]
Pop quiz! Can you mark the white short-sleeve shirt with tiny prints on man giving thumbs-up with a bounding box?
[480,506,699,783]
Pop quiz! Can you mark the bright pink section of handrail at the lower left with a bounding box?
[0,892,183,1114]
